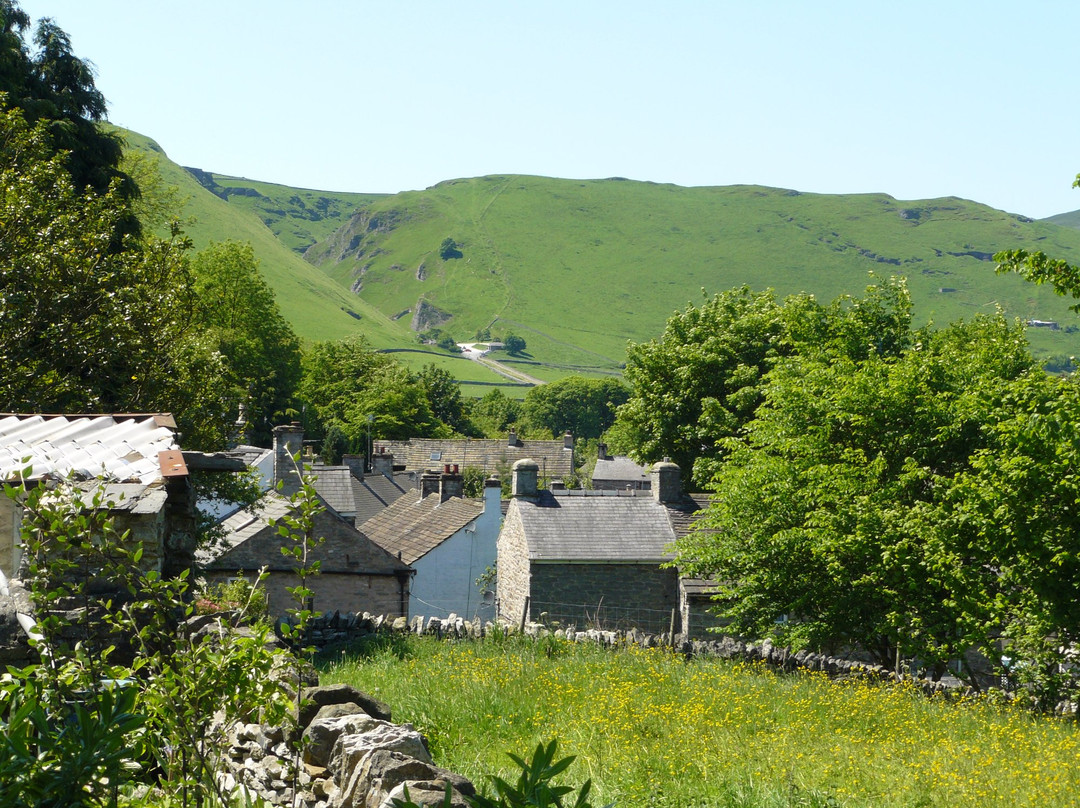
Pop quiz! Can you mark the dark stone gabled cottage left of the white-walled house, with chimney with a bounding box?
[199,426,414,617]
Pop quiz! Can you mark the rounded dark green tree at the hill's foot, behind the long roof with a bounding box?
[524,376,630,440]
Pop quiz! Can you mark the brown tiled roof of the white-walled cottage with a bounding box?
[360,493,484,564]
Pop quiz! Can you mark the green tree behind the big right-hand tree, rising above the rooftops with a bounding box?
[606,279,910,485]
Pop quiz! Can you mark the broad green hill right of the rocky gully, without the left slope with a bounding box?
[306,175,1080,364]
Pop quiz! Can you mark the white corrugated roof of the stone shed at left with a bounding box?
[0,415,179,485]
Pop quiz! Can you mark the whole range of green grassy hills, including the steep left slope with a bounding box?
[113,126,1080,375]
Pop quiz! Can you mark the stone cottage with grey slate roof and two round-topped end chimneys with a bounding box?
[498,459,707,633]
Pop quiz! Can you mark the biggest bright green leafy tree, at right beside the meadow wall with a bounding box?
[678,317,1080,691]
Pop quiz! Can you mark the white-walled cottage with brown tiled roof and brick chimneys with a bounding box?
[361,466,502,620]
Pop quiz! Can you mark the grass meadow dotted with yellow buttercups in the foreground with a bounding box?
[322,637,1080,808]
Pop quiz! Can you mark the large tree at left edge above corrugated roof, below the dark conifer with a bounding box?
[0,103,194,412]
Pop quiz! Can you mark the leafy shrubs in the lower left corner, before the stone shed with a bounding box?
[0,473,287,807]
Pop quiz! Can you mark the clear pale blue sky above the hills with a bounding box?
[14,0,1080,217]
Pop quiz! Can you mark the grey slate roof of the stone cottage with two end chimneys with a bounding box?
[516,491,700,563]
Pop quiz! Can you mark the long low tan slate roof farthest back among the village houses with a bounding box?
[375,437,573,479]
